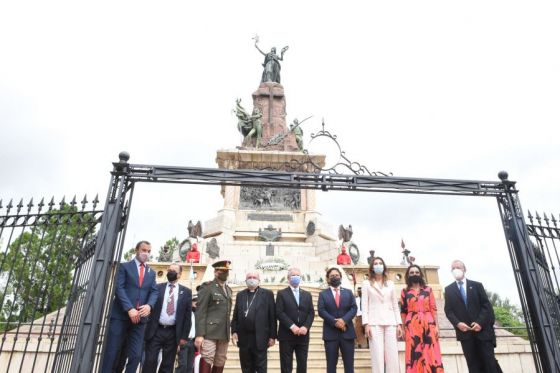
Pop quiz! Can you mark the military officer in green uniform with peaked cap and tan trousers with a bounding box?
[194,260,232,373]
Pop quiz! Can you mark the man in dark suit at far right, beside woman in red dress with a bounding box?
[444,260,497,373]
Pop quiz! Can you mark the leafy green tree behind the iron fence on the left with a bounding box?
[0,205,96,329]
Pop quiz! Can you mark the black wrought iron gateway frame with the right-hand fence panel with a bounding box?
[2,152,560,373]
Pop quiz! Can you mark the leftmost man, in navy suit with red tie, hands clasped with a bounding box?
[101,241,158,373]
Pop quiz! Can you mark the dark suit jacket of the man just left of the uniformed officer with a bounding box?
[144,282,192,345]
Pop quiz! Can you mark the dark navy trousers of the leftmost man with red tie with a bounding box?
[101,319,146,373]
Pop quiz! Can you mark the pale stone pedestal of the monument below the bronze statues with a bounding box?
[195,147,338,283]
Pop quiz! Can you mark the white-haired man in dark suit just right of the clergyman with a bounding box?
[276,268,315,373]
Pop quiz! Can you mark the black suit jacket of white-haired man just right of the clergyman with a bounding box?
[276,287,315,342]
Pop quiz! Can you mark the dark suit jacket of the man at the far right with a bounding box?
[444,279,495,341]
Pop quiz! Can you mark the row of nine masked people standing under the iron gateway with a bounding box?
[101,241,498,373]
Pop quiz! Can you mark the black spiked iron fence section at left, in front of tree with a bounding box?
[0,197,102,372]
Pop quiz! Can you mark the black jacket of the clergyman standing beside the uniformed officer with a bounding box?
[231,287,276,350]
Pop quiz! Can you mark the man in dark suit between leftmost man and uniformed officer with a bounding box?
[142,264,192,373]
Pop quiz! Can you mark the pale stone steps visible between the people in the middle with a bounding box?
[224,284,371,373]
